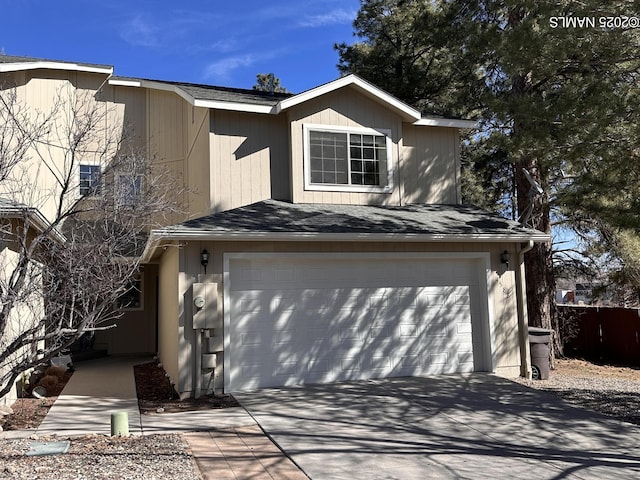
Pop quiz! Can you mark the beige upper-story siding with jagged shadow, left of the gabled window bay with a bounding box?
[210,111,288,212]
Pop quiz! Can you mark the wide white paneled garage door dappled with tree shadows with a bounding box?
[225,255,490,391]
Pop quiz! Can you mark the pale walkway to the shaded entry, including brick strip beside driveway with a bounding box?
[9,357,308,480]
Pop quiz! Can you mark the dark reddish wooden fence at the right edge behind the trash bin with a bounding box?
[558,305,640,366]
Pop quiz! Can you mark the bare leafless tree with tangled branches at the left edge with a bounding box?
[0,86,182,398]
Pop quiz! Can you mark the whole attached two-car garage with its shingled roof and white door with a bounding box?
[145,200,547,396]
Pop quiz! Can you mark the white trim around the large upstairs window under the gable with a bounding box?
[302,123,393,193]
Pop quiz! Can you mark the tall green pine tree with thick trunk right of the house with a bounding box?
[336,0,640,347]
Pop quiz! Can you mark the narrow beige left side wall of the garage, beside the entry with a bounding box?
[158,246,180,388]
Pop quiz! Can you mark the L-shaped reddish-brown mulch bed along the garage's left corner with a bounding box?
[133,362,240,414]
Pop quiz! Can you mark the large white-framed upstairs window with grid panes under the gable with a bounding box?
[304,125,392,192]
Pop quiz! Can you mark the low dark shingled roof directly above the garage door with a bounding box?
[152,200,548,241]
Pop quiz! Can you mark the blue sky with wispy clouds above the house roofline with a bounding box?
[0,0,360,93]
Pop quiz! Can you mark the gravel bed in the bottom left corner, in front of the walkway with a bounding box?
[0,435,202,480]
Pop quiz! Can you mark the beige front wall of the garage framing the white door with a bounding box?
[172,242,521,395]
